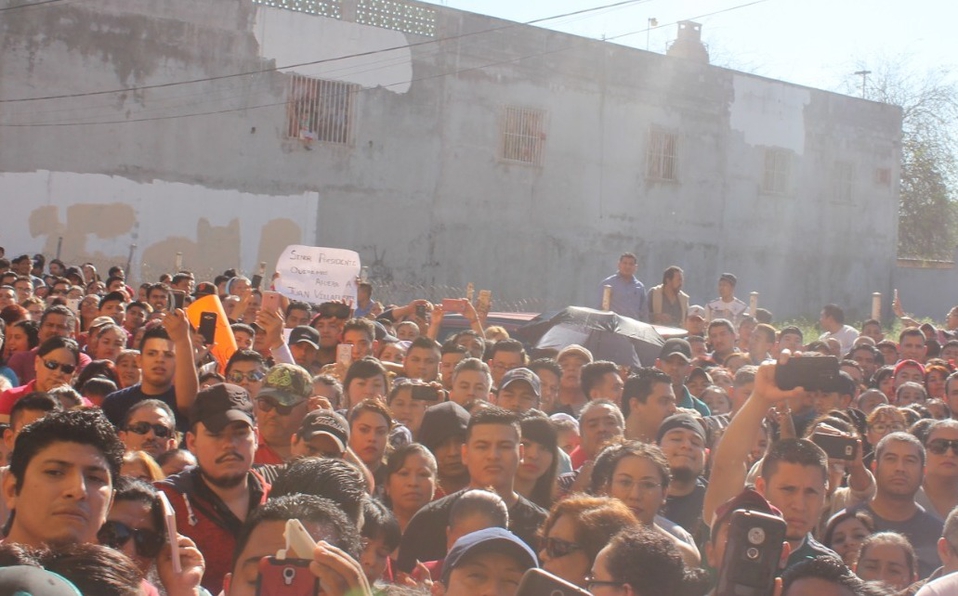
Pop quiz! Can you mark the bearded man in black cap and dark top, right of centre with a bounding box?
[657,414,707,536]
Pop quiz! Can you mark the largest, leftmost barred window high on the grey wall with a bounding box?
[286,75,359,145]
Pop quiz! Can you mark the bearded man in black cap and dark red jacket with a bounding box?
[157,383,269,594]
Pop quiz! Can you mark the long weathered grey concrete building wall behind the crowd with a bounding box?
[0,0,901,317]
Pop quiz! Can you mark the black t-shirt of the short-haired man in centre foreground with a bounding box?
[397,488,548,573]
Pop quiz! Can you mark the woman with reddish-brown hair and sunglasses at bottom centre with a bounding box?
[539,495,639,588]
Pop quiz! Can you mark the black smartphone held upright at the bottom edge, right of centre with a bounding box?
[715,510,786,596]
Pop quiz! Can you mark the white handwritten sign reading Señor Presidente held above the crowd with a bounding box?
[275,244,361,304]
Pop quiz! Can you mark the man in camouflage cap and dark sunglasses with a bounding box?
[254,364,313,464]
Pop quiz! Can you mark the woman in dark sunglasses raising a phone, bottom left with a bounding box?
[97,476,205,596]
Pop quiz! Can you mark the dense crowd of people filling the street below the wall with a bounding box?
[0,249,958,596]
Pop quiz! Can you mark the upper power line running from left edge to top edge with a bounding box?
[0,0,651,104]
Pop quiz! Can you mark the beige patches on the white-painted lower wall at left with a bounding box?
[29,203,302,281]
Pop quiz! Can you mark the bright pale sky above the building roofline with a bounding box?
[432,0,958,96]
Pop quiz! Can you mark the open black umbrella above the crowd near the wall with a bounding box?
[513,306,681,366]
